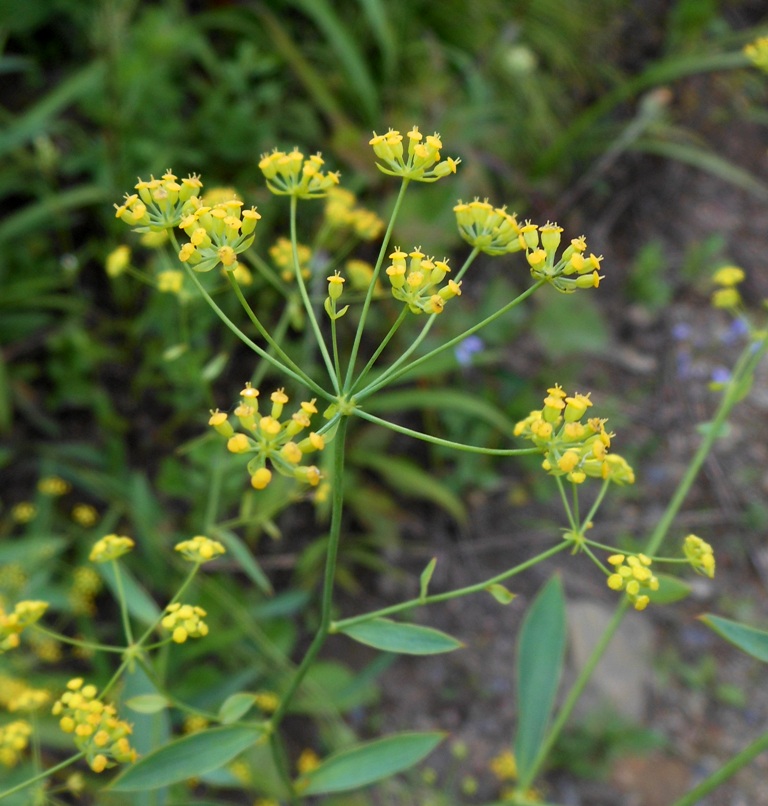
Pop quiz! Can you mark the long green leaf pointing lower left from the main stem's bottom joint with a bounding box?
[109,725,263,792]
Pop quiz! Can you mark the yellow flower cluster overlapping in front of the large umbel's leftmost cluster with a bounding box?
[179,197,261,272]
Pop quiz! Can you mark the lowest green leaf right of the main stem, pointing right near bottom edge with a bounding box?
[301,732,445,795]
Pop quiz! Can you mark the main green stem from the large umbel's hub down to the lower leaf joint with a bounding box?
[270,417,349,731]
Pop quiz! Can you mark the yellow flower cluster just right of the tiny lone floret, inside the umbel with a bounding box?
[387,247,461,313]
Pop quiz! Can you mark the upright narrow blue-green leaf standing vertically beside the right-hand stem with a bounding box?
[515,576,565,781]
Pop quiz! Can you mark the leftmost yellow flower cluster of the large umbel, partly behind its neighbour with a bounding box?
[115,168,203,232]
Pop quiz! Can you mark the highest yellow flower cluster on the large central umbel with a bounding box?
[368,126,461,182]
